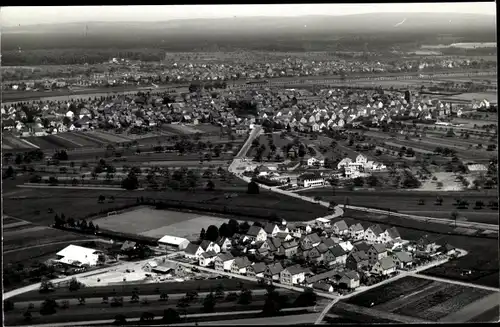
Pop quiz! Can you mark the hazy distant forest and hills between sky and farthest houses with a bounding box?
[1,13,496,66]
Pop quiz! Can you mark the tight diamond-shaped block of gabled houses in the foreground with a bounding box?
[154,219,454,292]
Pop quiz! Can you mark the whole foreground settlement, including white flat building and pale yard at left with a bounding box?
[50,218,460,295]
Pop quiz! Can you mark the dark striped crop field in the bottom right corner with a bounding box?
[347,277,494,322]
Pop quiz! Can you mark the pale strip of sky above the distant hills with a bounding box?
[0,2,496,26]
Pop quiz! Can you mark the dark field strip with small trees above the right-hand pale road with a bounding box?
[298,188,498,224]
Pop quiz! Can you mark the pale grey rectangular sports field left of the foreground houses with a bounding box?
[94,208,242,241]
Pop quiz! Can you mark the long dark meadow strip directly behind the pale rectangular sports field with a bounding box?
[4,187,328,227]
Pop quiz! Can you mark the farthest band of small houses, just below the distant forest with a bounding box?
[2,54,480,91]
